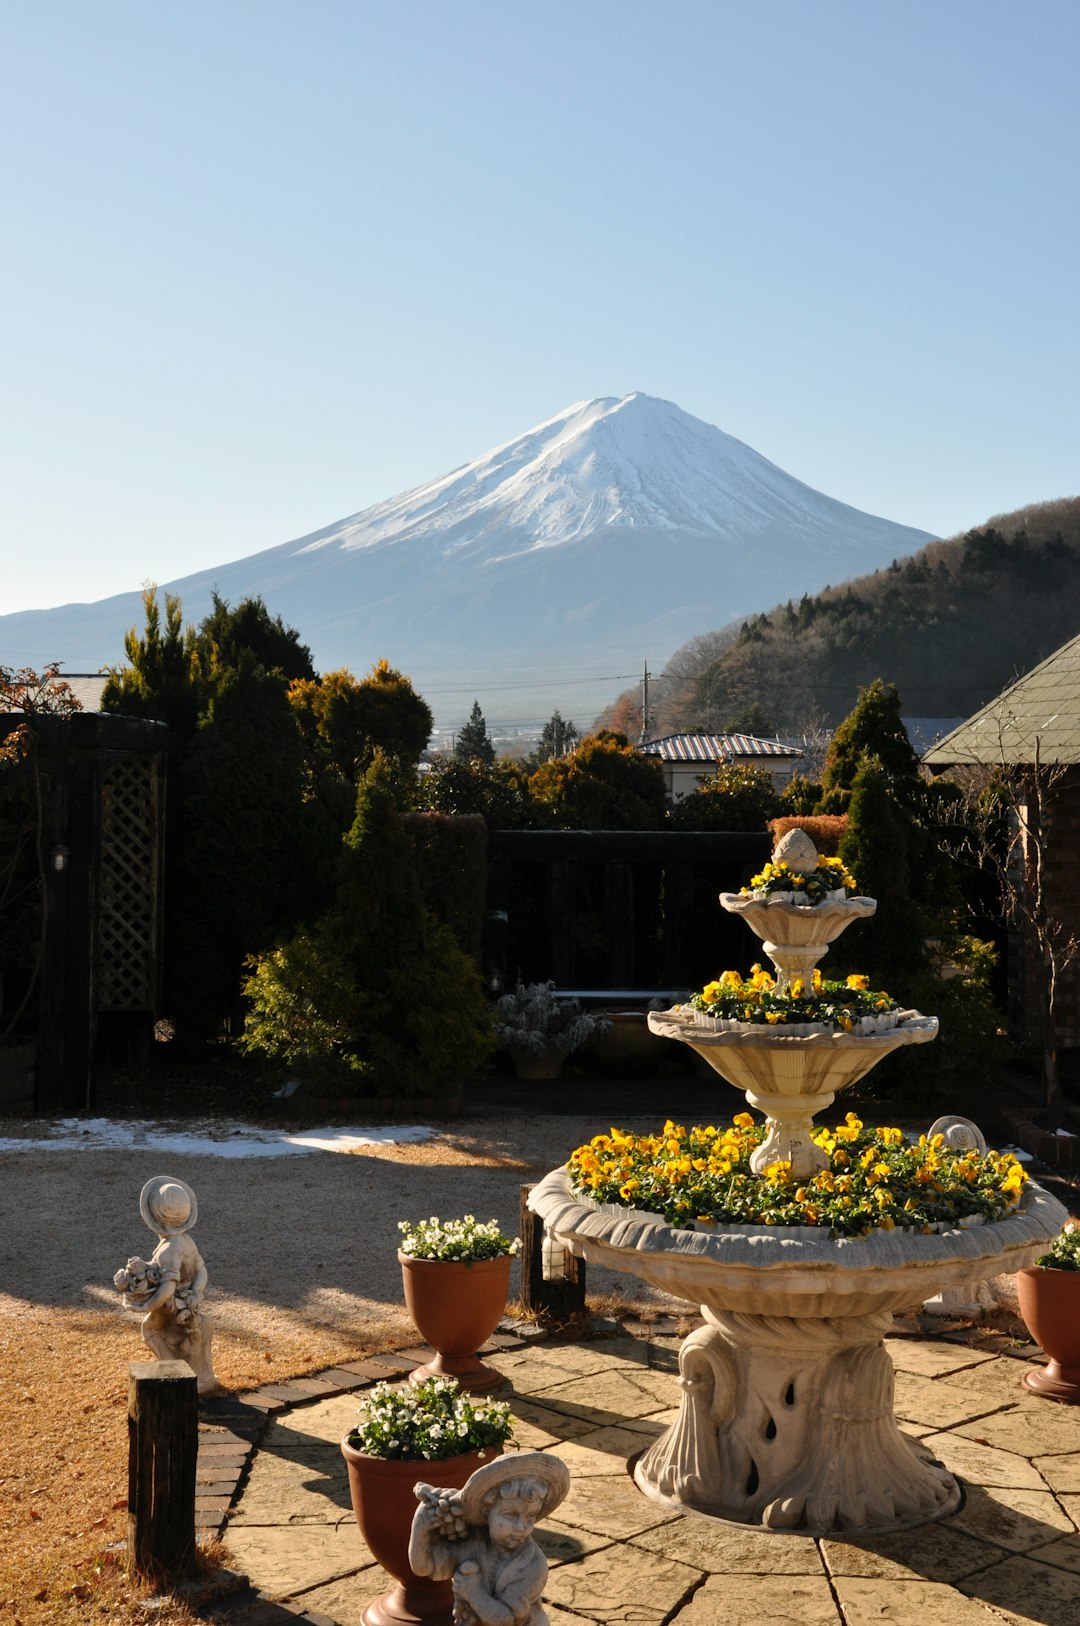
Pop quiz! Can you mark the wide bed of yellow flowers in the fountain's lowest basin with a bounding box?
[568,1112,1026,1236]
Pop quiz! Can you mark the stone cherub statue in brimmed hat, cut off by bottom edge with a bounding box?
[408,1450,569,1626]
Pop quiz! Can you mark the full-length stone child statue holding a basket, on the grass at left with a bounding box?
[112,1174,221,1395]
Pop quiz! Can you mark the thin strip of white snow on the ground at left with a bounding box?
[0,1119,436,1158]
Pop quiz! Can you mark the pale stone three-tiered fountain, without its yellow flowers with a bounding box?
[530,837,1065,1535]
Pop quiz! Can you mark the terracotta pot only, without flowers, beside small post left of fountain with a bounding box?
[397,1252,511,1395]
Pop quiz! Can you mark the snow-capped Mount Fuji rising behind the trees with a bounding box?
[0,393,930,725]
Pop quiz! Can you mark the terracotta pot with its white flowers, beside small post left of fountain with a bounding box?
[397,1215,520,1395]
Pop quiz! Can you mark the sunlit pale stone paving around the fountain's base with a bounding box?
[198,1324,1080,1626]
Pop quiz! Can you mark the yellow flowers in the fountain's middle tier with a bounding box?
[683,966,903,1036]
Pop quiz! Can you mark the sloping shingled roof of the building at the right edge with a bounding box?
[922,636,1080,767]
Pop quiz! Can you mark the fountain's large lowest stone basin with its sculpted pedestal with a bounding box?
[529,1169,1065,1535]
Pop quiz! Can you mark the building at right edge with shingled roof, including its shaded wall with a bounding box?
[922,637,1080,1050]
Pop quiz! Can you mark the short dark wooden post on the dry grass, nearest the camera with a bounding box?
[127,1361,198,1585]
